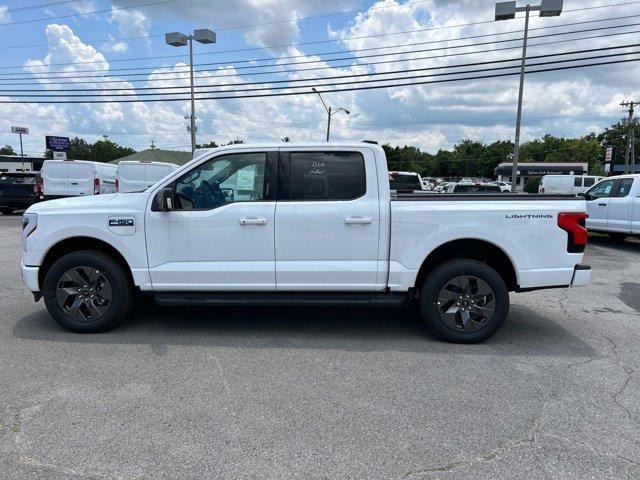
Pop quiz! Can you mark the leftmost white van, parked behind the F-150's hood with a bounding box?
[41,160,117,200]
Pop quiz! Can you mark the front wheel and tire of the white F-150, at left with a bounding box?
[43,250,134,333]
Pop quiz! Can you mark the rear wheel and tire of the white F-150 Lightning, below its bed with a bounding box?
[420,259,509,343]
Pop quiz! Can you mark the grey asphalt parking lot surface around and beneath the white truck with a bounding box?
[0,216,640,480]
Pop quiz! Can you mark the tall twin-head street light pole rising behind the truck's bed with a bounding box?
[496,0,563,193]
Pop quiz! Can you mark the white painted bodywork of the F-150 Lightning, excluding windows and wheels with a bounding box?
[23,142,592,292]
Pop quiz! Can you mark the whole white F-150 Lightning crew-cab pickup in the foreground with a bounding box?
[22,142,591,343]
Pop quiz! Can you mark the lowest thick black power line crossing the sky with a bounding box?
[0,59,640,104]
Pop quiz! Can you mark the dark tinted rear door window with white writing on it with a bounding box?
[289,152,366,200]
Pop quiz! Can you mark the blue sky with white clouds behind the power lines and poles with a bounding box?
[0,0,640,153]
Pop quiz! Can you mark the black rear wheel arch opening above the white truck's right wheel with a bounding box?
[415,238,518,291]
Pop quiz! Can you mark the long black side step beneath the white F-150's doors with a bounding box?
[155,292,409,307]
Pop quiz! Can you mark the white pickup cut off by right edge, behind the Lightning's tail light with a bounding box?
[581,174,640,240]
